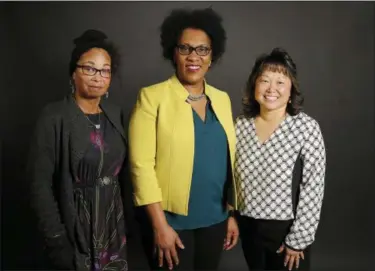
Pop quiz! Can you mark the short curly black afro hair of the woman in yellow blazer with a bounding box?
[160,8,227,65]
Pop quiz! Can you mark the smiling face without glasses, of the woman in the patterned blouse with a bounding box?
[255,69,292,112]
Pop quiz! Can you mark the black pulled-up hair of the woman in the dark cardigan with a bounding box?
[69,29,120,76]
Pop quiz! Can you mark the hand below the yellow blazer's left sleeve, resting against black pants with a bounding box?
[154,225,185,270]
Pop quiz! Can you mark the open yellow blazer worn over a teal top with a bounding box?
[129,75,237,215]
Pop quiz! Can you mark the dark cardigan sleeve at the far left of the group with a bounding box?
[27,109,73,268]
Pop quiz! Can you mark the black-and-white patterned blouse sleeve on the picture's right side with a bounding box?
[285,120,326,250]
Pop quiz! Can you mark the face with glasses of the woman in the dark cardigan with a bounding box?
[72,48,111,99]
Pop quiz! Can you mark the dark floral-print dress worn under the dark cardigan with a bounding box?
[74,113,128,271]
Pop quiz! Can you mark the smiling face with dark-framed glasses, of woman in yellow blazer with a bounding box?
[174,28,212,85]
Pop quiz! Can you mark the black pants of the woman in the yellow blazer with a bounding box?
[140,211,227,270]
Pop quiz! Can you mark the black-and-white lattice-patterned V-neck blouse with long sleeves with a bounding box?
[234,113,326,250]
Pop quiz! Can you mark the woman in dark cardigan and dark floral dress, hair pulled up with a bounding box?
[28,30,128,270]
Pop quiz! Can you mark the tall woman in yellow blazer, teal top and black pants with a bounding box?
[129,9,238,270]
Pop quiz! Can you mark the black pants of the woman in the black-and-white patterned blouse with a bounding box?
[237,215,310,270]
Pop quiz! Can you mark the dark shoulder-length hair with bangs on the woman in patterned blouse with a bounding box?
[242,48,304,117]
